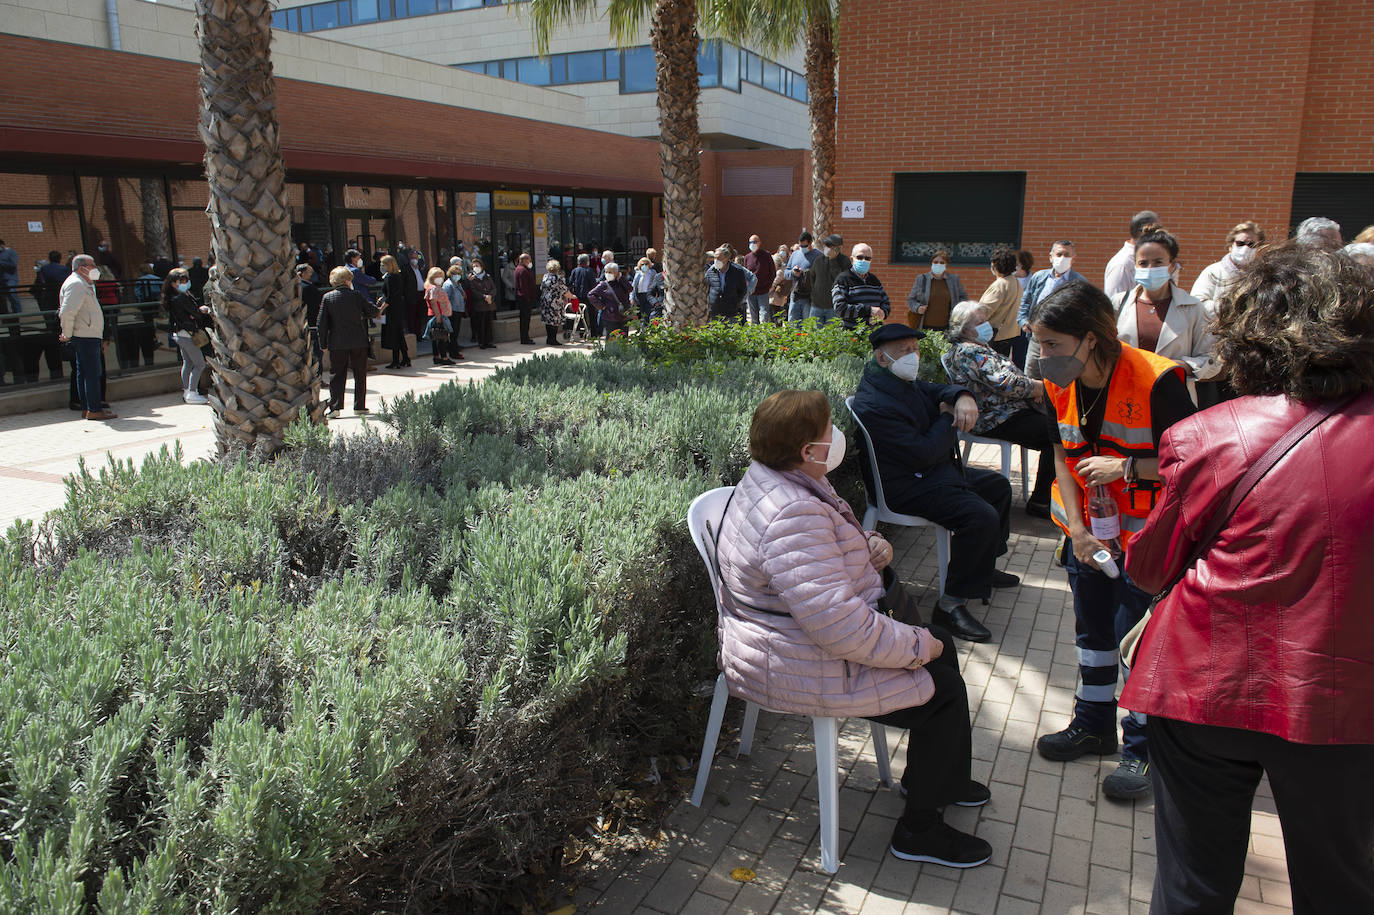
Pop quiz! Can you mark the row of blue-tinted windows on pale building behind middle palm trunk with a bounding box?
[456,38,807,102]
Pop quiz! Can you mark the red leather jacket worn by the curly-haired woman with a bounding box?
[1121,392,1374,743]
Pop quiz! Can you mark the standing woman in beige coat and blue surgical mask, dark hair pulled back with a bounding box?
[1112,225,1221,398]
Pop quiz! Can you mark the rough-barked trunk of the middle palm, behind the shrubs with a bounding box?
[650,0,709,324]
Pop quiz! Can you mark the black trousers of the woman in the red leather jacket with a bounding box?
[1150,716,1374,915]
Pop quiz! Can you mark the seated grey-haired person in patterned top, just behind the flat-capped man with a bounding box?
[945,301,1054,518]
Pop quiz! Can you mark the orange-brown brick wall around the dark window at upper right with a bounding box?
[835,0,1374,316]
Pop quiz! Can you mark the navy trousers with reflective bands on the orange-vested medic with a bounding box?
[1063,550,1150,760]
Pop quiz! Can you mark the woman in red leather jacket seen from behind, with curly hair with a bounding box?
[1121,245,1374,912]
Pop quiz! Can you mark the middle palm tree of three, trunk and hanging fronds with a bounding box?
[513,0,708,324]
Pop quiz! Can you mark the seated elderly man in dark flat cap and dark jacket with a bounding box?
[853,324,1021,642]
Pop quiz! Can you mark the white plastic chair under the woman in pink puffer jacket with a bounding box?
[687,486,892,874]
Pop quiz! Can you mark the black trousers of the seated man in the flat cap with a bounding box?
[892,467,1011,599]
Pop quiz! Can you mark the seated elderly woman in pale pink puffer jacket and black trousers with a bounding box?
[719,390,992,867]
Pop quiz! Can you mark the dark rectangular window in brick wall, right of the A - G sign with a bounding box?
[892,172,1026,264]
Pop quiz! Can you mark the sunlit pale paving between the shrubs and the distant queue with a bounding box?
[0,337,587,530]
